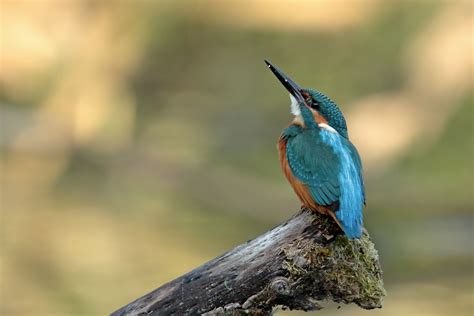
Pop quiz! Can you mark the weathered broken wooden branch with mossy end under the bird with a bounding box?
[112,211,385,316]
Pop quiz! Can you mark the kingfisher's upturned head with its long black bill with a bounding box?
[265,60,348,138]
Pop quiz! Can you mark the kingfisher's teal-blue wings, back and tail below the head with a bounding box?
[286,129,365,238]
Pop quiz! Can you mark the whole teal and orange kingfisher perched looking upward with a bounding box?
[265,60,365,239]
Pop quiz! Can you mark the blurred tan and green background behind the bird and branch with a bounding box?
[0,0,474,316]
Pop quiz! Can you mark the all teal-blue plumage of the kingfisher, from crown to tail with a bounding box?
[282,90,365,238]
